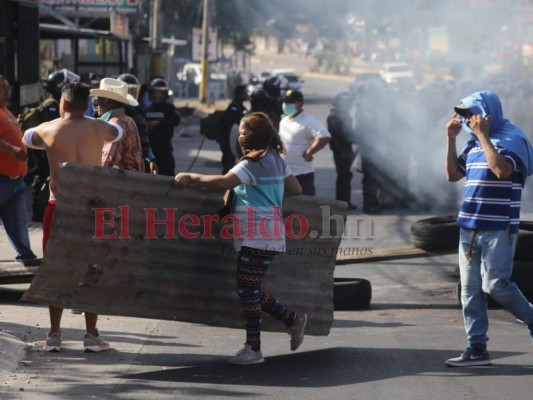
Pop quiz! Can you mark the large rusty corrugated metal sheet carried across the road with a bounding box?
[24,165,346,335]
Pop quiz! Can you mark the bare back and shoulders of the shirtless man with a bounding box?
[25,113,118,198]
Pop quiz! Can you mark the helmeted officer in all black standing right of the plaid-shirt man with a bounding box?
[145,102,181,176]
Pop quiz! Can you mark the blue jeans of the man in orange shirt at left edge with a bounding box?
[0,175,37,261]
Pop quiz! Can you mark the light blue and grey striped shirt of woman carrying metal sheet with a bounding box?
[230,150,292,251]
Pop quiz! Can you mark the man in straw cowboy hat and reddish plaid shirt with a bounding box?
[91,78,144,172]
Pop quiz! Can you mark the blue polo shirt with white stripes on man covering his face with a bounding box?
[457,142,524,233]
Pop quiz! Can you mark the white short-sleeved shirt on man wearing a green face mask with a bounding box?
[279,111,331,176]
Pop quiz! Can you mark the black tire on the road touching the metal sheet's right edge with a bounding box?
[333,278,372,311]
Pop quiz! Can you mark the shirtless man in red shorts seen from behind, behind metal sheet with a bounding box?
[24,82,122,352]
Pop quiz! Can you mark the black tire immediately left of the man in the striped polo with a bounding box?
[411,215,459,251]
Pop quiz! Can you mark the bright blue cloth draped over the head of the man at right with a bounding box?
[459,91,533,182]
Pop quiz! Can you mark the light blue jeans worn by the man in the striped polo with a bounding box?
[459,228,533,345]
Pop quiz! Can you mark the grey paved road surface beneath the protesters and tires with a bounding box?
[0,50,533,400]
